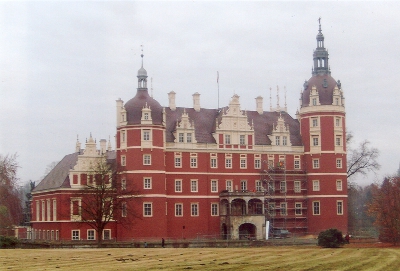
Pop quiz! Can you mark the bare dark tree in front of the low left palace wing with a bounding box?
[73,157,137,247]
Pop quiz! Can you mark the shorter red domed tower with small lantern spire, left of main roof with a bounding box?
[116,54,167,239]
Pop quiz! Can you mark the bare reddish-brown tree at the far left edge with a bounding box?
[0,154,22,236]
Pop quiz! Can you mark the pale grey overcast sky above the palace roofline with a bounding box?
[0,1,400,187]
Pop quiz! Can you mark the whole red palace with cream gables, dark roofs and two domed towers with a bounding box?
[31,22,347,241]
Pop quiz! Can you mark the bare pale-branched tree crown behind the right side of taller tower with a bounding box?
[346,137,381,178]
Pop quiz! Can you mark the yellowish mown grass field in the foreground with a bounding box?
[0,246,400,271]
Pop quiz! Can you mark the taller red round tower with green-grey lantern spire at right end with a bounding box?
[298,20,347,233]
